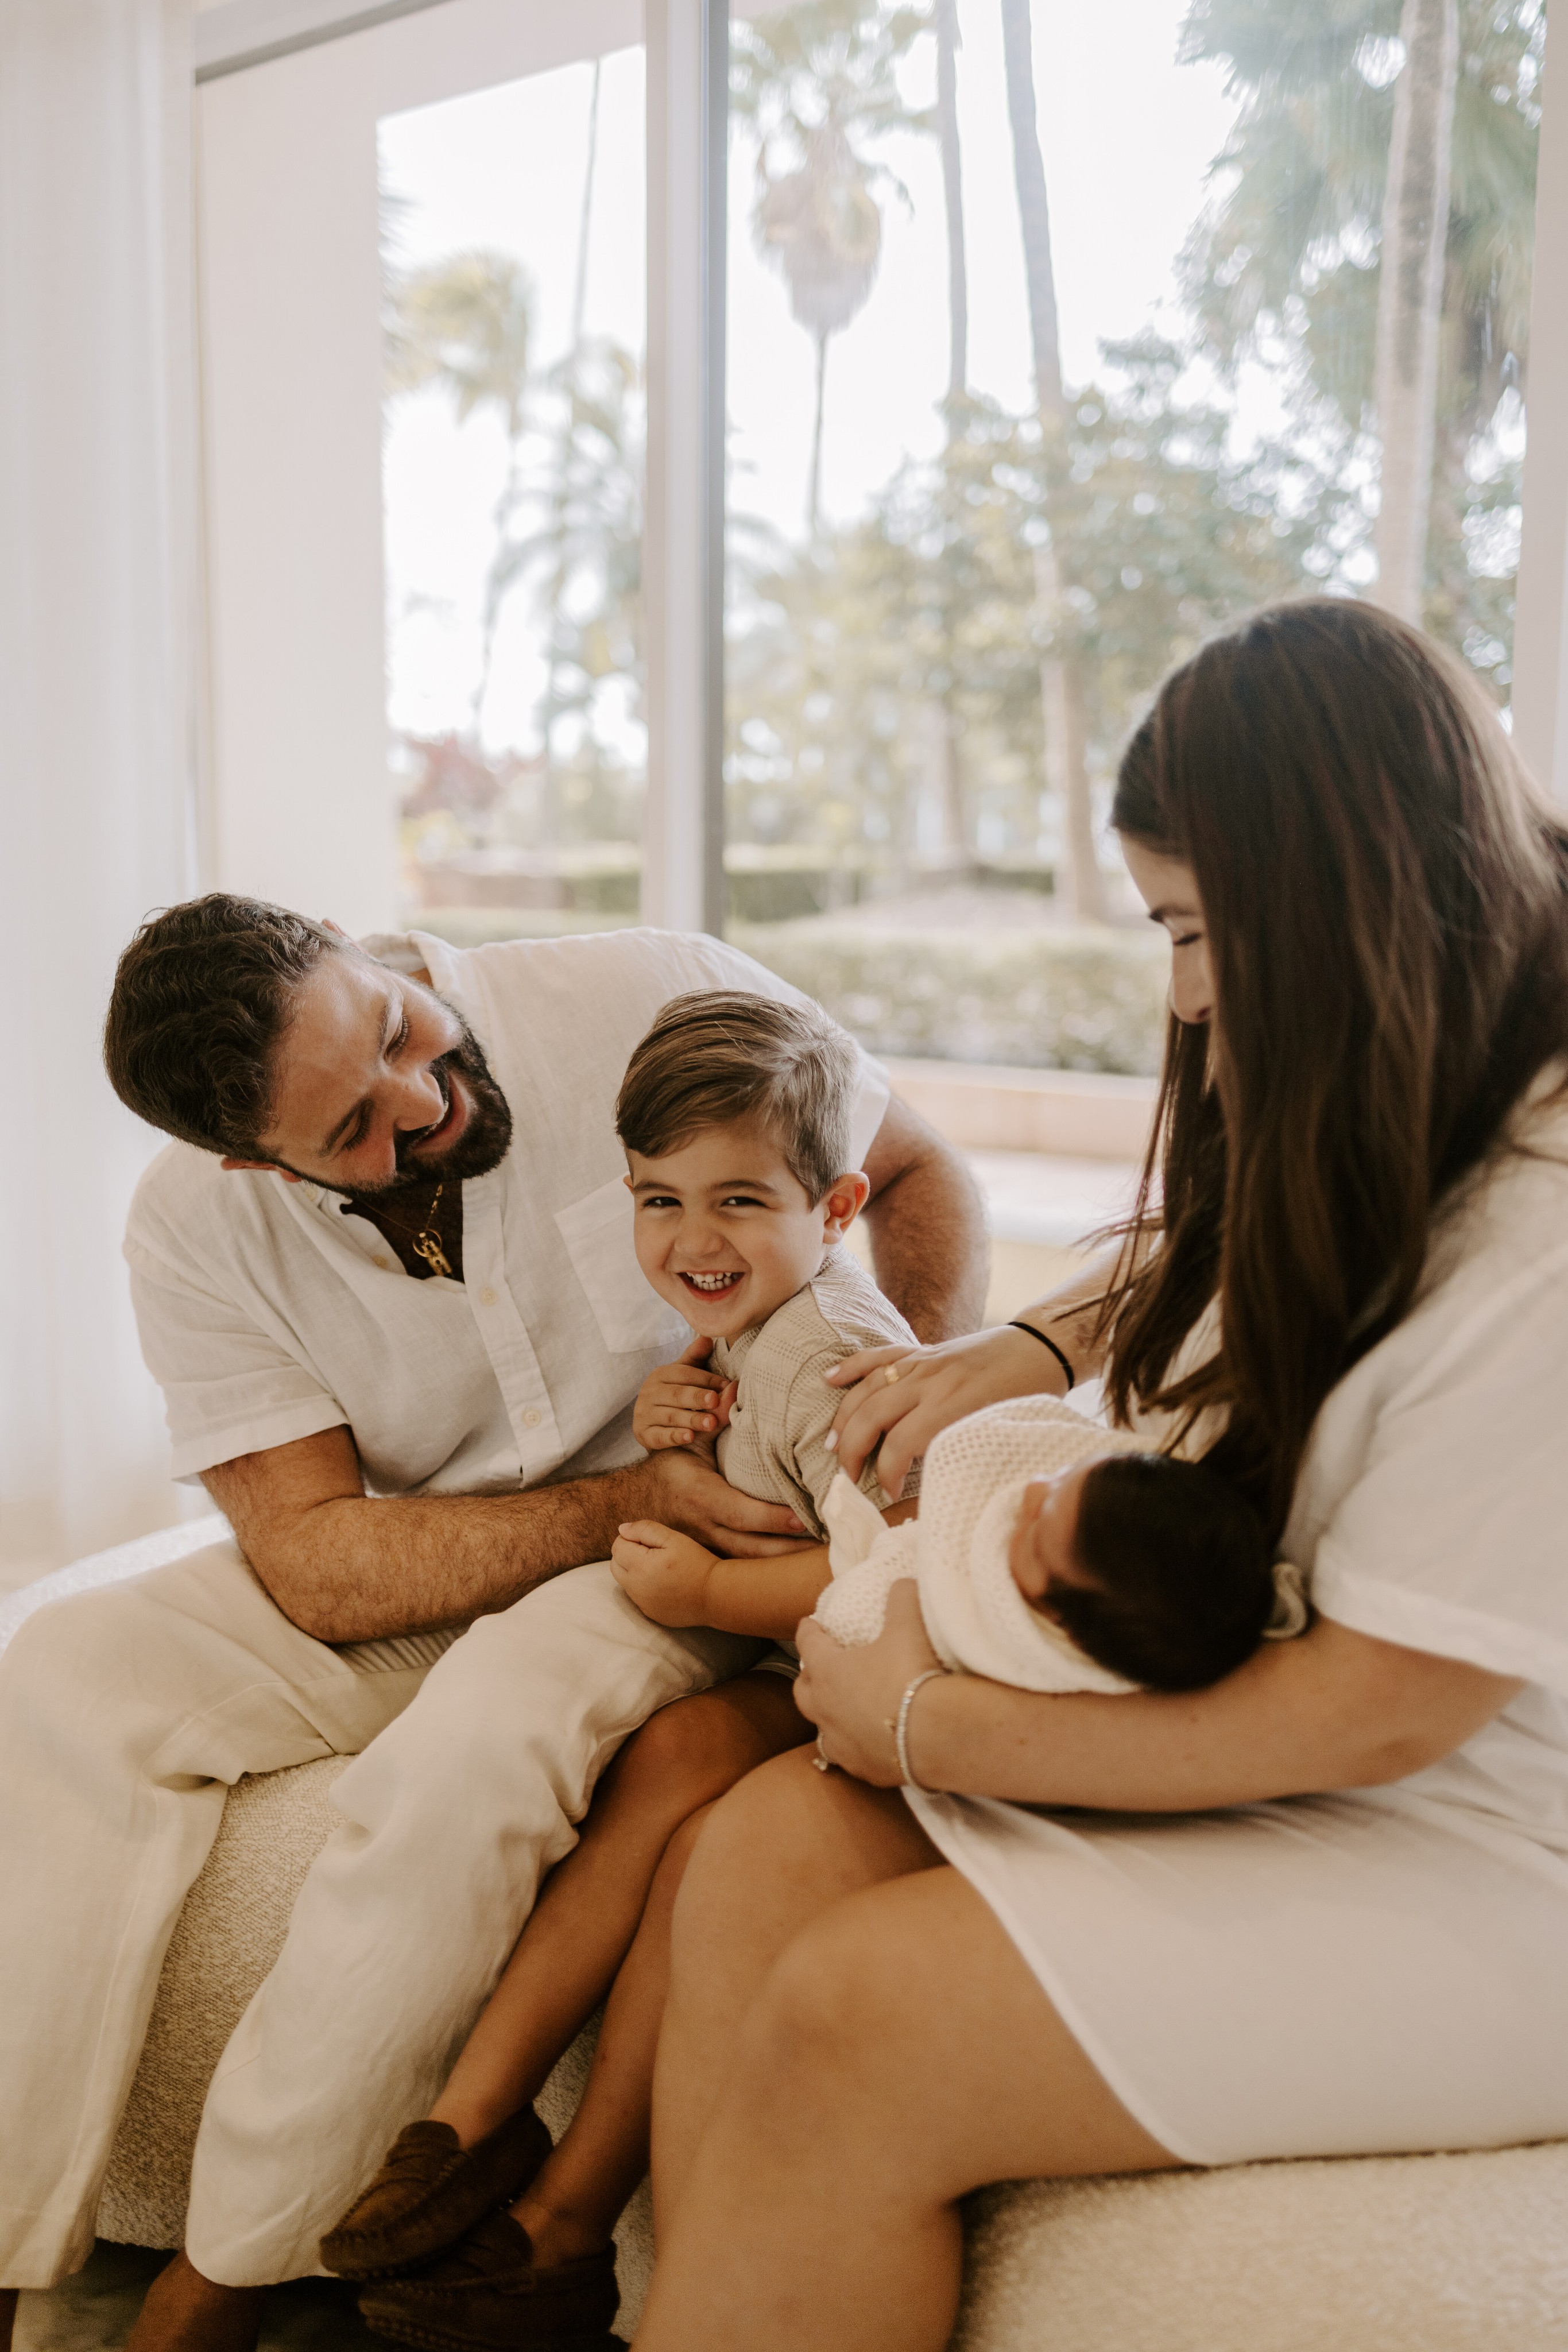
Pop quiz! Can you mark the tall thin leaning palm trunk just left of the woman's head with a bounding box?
[1001,0,1105,922]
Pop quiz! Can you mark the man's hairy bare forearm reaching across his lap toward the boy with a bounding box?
[207,1456,649,1642]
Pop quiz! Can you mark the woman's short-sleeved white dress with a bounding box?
[907,1108,1568,2164]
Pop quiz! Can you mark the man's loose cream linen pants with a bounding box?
[0,1543,757,2286]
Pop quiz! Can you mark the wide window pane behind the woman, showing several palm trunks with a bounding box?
[726,0,1544,1070]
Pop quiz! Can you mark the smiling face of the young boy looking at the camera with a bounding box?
[625,1120,870,1339]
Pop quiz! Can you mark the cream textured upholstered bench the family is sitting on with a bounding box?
[0,1524,1568,2352]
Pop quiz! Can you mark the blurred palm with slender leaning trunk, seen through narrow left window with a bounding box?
[385,252,533,736]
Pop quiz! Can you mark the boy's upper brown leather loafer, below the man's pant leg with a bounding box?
[322,2107,550,2279]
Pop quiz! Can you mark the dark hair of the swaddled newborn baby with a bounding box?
[1051,1453,1274,1691]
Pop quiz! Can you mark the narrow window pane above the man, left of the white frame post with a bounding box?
[378,49,646,941]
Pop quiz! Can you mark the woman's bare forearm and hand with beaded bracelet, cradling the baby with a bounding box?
[797,1585,1523,1813]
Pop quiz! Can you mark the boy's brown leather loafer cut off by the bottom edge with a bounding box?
[359,2213,625,2352]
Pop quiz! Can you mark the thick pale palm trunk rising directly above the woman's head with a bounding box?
[1373,0,1460,621]
